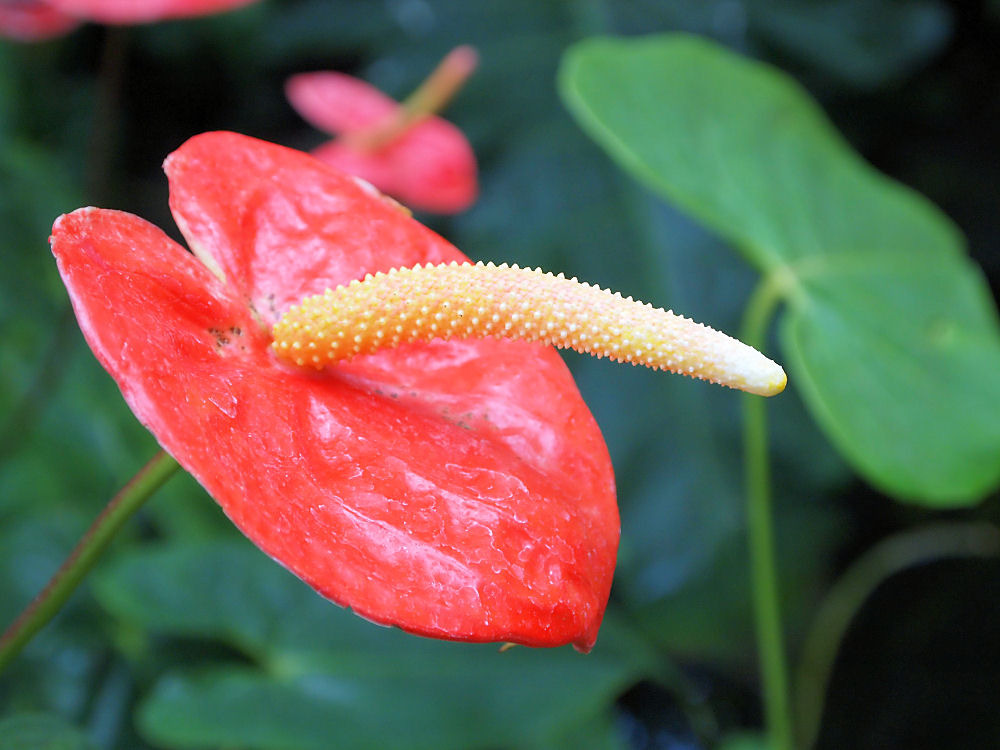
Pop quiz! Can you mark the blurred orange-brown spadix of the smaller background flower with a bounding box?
[341,45,479,151]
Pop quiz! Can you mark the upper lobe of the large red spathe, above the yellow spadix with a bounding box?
[164,133,454,325]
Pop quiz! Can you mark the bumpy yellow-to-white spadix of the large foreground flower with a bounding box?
[274,262,786,396]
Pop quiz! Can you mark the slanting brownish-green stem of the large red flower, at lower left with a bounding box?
[0,451,178,672]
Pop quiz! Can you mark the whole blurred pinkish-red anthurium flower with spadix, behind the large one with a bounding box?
[285,47,478,214]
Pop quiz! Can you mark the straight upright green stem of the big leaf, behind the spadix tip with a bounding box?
[741,277,792,750]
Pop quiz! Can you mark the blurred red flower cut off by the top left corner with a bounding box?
[0,0,256,41]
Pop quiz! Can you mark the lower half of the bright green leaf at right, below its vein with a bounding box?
[781,253,1000,506]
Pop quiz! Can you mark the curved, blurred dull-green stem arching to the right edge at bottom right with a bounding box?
[795,522,1000,748]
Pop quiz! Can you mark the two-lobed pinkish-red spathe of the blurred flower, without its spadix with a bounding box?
[285,72,478,213]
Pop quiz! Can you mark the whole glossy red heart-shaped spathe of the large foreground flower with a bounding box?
[52,133,618,649]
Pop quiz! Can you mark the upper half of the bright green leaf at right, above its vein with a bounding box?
[560,35,962,271]
